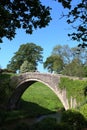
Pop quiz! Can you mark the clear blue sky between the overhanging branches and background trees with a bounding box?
[0,0,78,72]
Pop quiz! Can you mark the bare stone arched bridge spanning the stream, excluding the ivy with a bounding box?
[8,72,75,110]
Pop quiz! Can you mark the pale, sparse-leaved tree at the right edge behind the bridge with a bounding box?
[63,47,87,77]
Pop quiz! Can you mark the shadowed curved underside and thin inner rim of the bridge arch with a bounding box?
[8,79,62,109]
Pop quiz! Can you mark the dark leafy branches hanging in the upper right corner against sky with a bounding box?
[58,0,87,47]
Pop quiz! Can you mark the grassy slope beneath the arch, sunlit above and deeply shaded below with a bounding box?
[0,82,63,123]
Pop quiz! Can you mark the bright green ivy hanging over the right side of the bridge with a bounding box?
[59,77,87,105]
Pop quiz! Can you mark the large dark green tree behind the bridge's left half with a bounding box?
[7,43,43,72]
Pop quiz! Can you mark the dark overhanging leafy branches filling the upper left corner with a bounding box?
[0,0,51,42]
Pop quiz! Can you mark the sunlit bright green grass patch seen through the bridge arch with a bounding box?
[22,82,63,111]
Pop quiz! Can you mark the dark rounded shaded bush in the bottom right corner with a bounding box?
[61,110,87,130]
